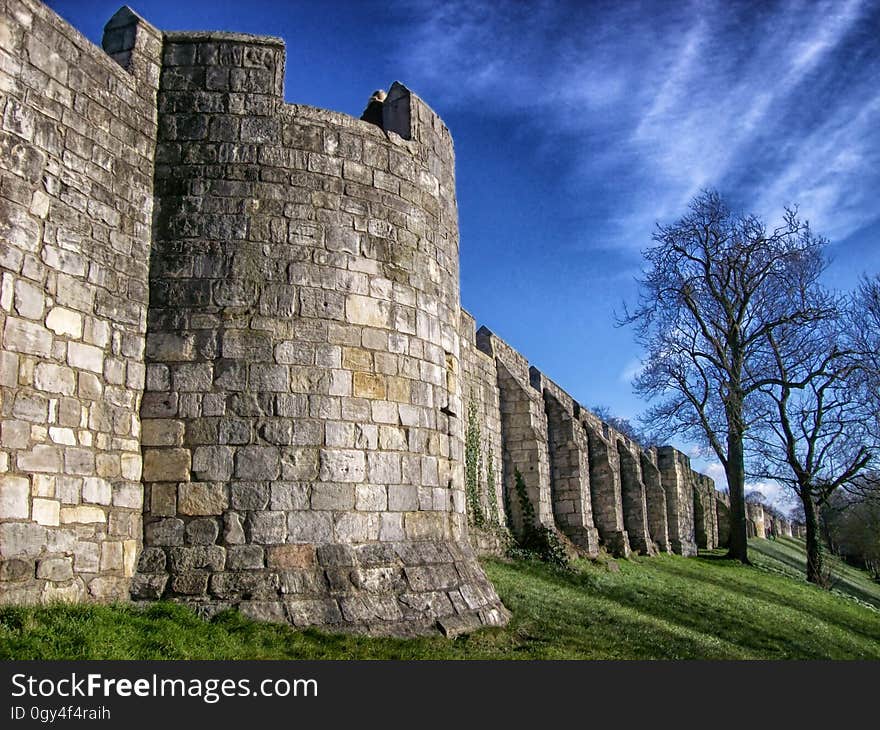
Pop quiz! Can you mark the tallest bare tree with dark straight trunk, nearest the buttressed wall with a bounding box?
[621,191,826,562]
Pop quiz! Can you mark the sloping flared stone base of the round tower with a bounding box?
[132,540,510,636]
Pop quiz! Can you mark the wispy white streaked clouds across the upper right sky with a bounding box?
[396,0,880,247]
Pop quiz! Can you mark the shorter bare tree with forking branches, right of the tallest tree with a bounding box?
[750,306,875,585]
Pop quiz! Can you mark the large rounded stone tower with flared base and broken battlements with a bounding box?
[132,28,505,632]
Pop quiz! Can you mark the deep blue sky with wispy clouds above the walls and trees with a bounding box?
[48,0,880,512]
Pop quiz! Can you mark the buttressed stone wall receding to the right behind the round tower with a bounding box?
[461,322,727,556]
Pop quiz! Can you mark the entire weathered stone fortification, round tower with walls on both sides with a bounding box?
[0,0,756,633]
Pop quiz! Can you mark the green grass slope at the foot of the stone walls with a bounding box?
[0,540,880,659]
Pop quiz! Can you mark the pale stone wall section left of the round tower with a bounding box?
[0,0,161,602]
